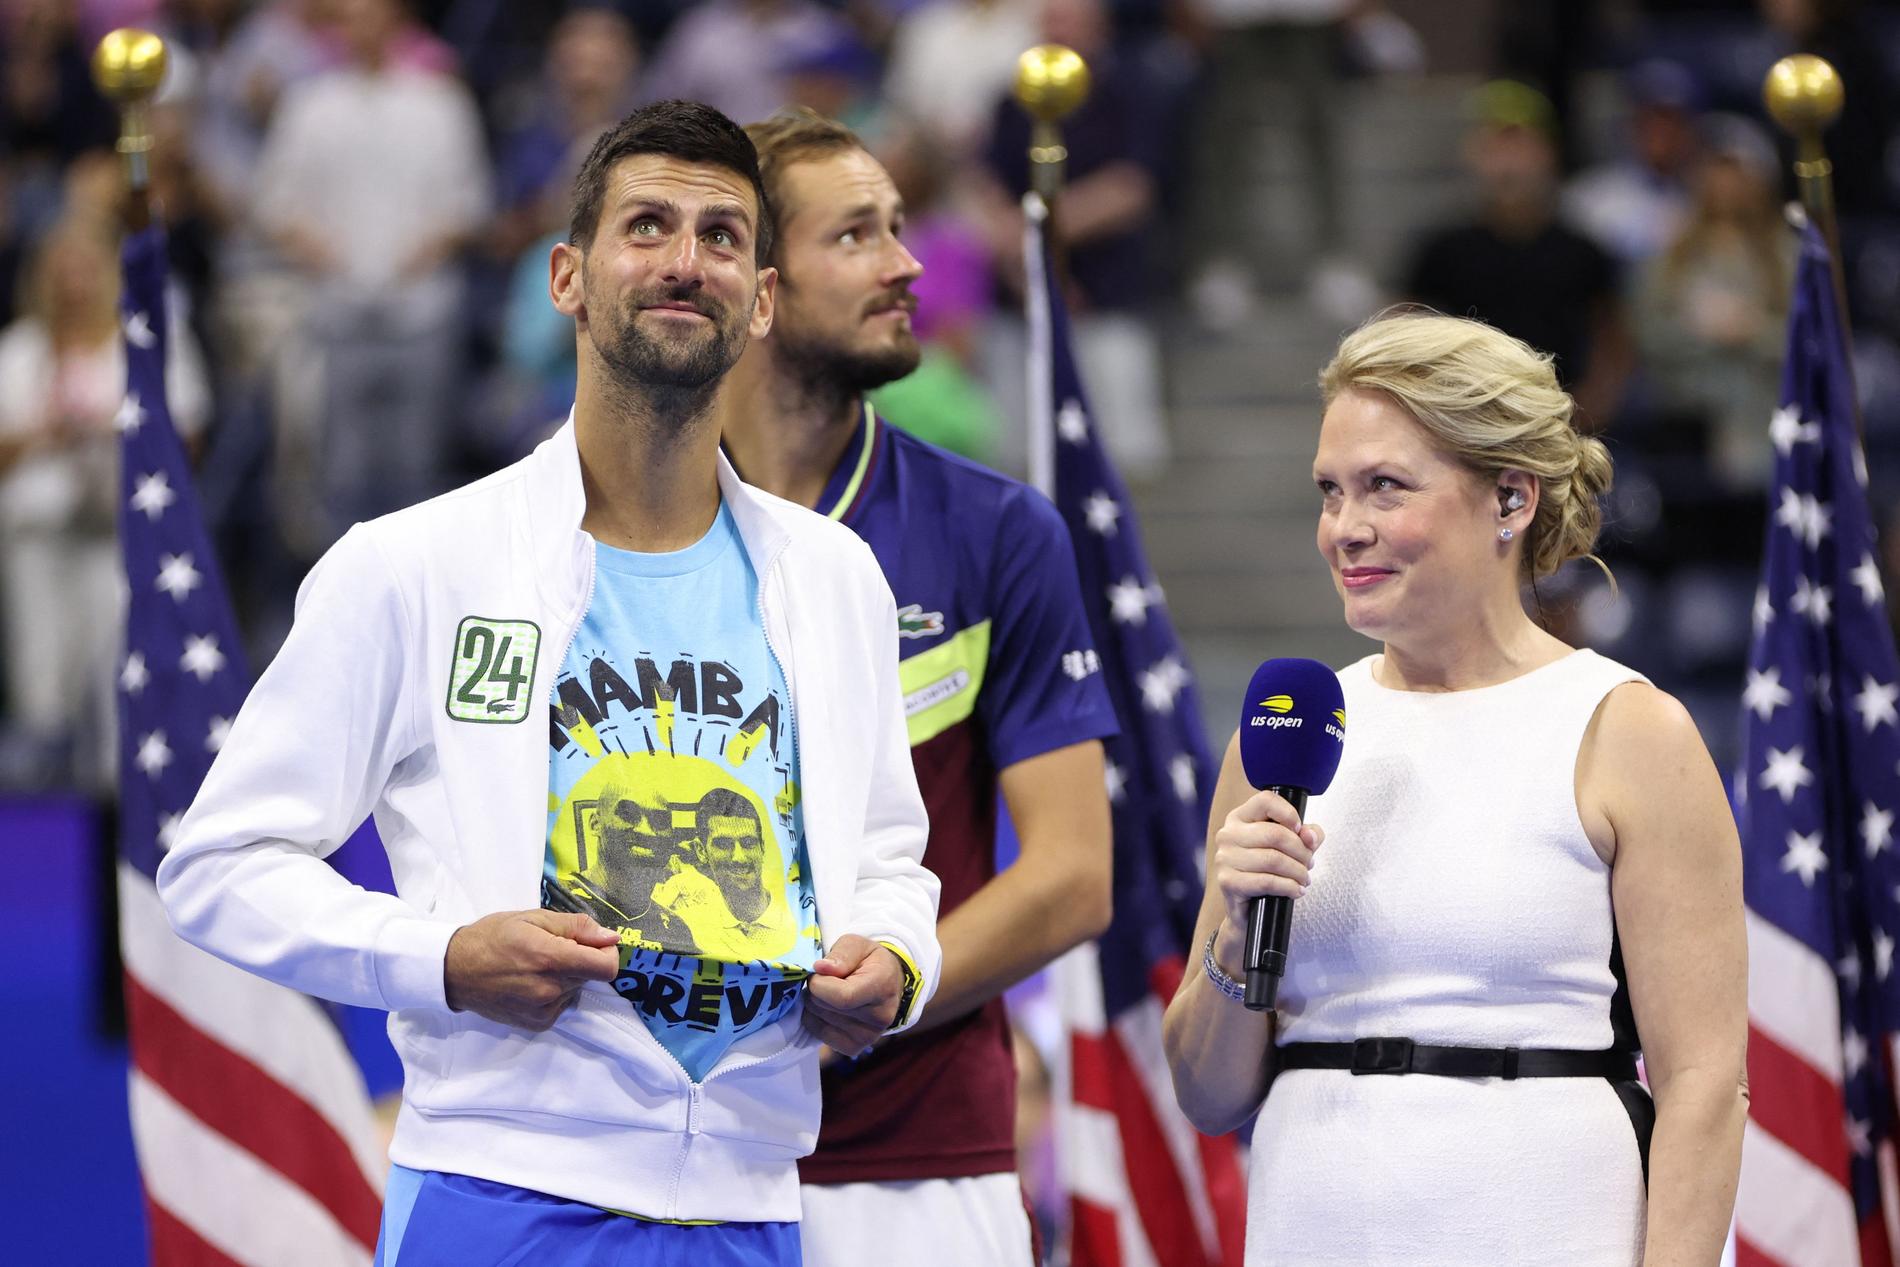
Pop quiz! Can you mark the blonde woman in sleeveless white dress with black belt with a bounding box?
[1167,313,1746,1267]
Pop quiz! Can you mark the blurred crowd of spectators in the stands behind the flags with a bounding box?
[0,0,1900,788]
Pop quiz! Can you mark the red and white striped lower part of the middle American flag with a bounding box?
[1056,944,1246,1267]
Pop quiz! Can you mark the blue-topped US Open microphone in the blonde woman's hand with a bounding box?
[1241,657,1345,1012]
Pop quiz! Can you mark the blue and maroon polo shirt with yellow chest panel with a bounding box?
[741,407,1115,1183]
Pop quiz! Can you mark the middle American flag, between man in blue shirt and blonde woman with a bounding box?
[1024,194,1246,1267]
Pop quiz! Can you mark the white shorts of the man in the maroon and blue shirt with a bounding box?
[798,1174,1036,1267]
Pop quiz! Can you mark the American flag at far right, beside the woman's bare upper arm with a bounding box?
[1735,226,1900,1267]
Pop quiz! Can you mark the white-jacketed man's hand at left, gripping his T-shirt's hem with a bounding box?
[443,910,619,1030]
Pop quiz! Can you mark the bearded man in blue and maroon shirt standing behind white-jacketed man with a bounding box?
[722,112,1115,1267]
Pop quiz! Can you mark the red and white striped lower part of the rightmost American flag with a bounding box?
[1735,912,1862,1267]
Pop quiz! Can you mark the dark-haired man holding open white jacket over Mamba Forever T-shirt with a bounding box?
[160,103,939,1267]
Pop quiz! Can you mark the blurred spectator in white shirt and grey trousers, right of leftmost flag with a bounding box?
[255,0,488,553]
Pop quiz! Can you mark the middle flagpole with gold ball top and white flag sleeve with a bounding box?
[1017,44,1089,498]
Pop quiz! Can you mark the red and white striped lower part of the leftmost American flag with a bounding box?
[118,864,388,1267]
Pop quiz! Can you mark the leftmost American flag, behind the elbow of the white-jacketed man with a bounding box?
[118,228,386,1267]
